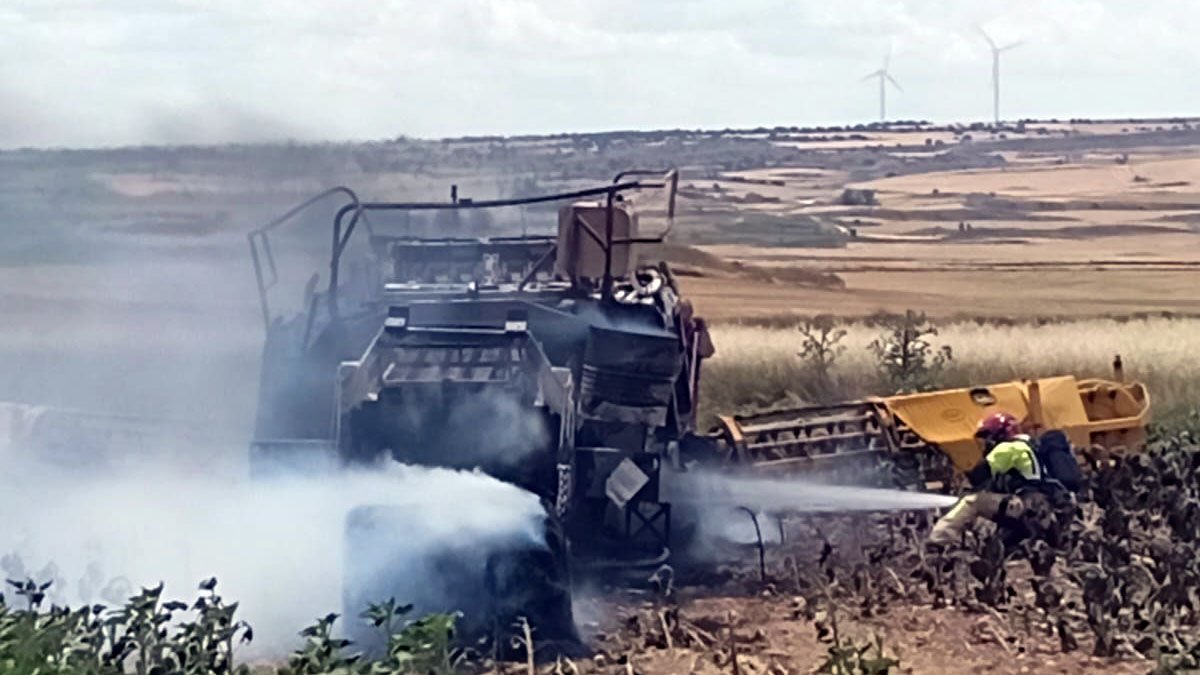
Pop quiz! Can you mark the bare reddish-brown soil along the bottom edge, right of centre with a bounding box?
[583,591,1152,675]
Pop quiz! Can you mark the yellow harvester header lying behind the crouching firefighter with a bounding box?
[718,360,1150,490]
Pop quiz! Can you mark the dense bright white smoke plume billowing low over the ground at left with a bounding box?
[0,449,545,656]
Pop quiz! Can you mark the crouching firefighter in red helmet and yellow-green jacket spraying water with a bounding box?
[929,412,1043,546]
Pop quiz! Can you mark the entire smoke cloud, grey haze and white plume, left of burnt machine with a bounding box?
[0,147,556,653]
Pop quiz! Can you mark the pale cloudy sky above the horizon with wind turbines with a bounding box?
[0,0,1200,147]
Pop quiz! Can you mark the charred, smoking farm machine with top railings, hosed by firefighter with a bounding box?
[250,171,713,638]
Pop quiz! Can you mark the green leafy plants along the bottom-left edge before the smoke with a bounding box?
[0,579,464,675]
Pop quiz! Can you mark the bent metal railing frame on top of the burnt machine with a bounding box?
[247,168,679,328]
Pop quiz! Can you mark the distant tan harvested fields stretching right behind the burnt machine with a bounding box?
[683,125,1200,319]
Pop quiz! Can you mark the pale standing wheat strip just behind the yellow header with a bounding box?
[701,317,1200,425]
